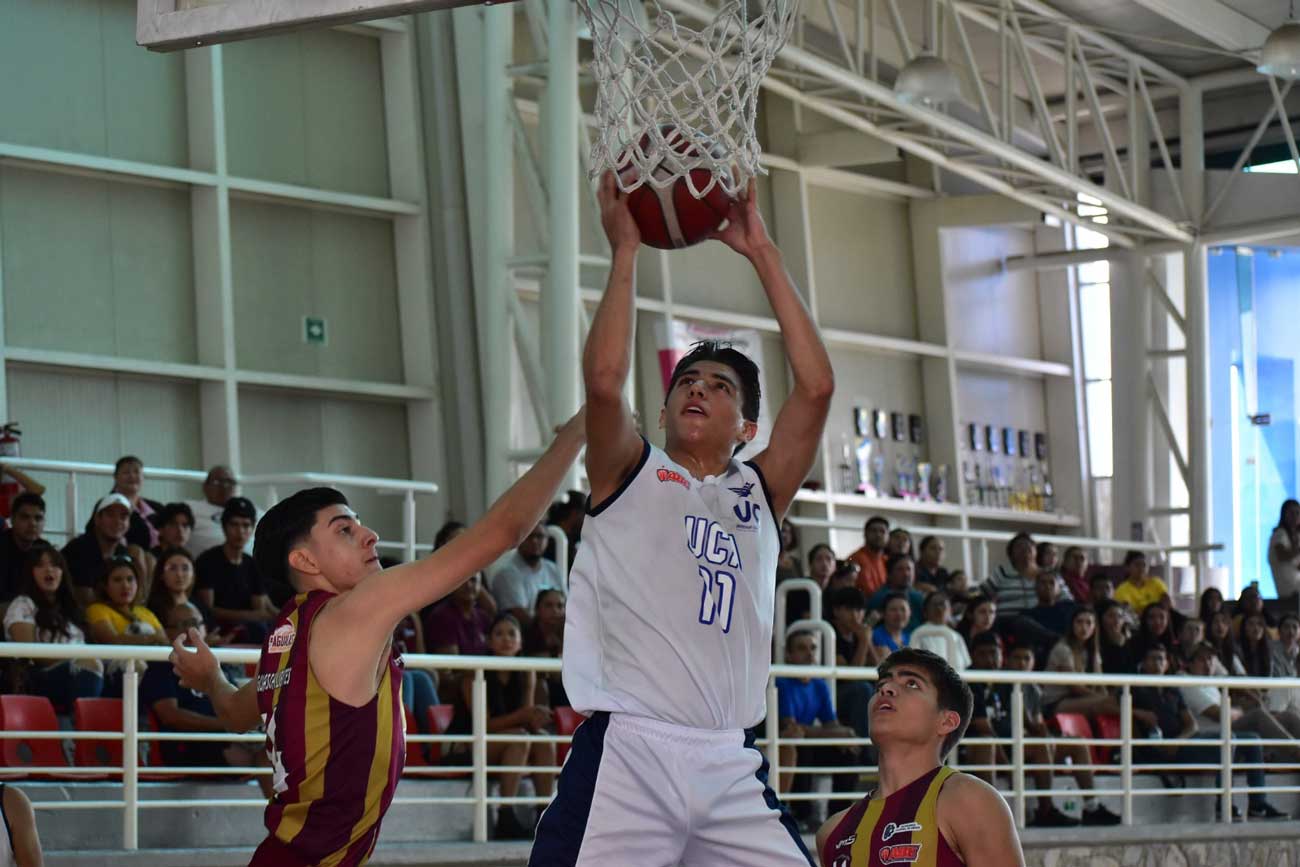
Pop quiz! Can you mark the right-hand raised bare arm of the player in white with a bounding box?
[714,181,835,520]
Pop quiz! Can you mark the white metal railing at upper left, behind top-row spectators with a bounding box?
[3,458,438,560]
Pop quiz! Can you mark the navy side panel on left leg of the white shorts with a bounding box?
[528,712,608,867]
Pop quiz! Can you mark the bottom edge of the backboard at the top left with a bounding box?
[135,0,480,51]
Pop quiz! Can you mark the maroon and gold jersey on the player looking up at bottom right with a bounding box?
[819,766,962,867]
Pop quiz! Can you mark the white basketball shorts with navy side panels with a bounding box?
[528,712,813,867]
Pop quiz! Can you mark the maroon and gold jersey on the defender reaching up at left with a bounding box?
[254,590,406,867]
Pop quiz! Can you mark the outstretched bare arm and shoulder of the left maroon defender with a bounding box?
[309,412,585,706]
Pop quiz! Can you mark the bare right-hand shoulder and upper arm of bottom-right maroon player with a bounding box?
[939,773,1024,867]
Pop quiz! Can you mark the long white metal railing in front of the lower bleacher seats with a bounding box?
[0,642,1300,849]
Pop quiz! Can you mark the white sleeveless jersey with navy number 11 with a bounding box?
[564,442,780,731]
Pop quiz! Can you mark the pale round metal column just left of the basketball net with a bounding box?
[541,0,580,452]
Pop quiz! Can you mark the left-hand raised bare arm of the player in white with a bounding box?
[582,172,642,503]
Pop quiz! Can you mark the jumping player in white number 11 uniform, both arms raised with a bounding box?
[529,175,833,867]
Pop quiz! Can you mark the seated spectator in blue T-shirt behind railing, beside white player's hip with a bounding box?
[776,629,858,828]
